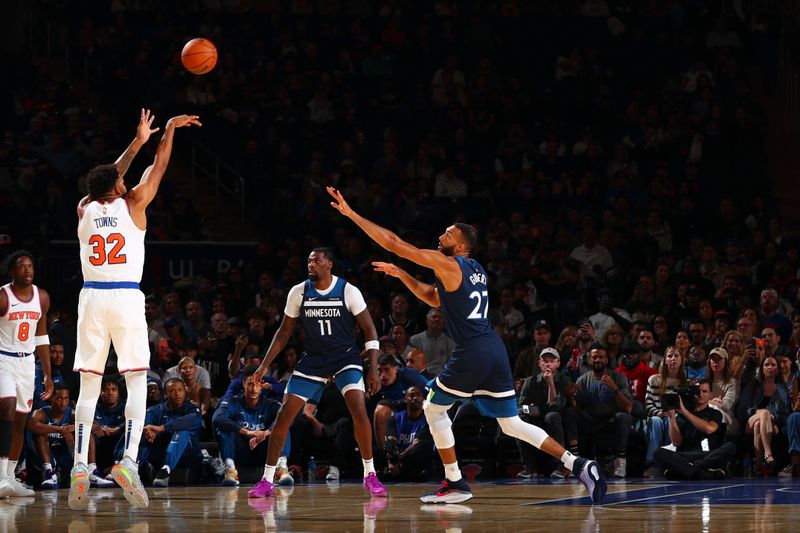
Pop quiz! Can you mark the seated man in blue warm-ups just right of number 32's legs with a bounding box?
[139,378,203,487]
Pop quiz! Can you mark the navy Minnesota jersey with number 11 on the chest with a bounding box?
[300,278,355,355]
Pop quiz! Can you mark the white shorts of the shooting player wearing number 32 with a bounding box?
[74,287,150,375]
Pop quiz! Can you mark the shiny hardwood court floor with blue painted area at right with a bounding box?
[0,479,800,533]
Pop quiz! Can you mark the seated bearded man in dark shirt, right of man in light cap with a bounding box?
[575,344,633,478]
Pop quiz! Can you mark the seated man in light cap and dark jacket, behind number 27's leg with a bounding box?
[517,348,578,478]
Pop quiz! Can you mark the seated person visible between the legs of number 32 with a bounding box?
[92,375,125,471]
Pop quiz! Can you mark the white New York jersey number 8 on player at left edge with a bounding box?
[0,283,42,357]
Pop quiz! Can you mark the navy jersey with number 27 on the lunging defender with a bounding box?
[436,256,494,345]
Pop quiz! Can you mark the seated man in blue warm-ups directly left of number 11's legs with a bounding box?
[213,365,294,487]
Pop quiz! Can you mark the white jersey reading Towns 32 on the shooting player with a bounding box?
[78,198,146,283]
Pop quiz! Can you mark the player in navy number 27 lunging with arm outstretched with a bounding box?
[328,187,606,503]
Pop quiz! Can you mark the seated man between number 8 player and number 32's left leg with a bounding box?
[27,384,114,489]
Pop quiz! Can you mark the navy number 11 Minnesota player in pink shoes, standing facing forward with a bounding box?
[252,248,386,498]
